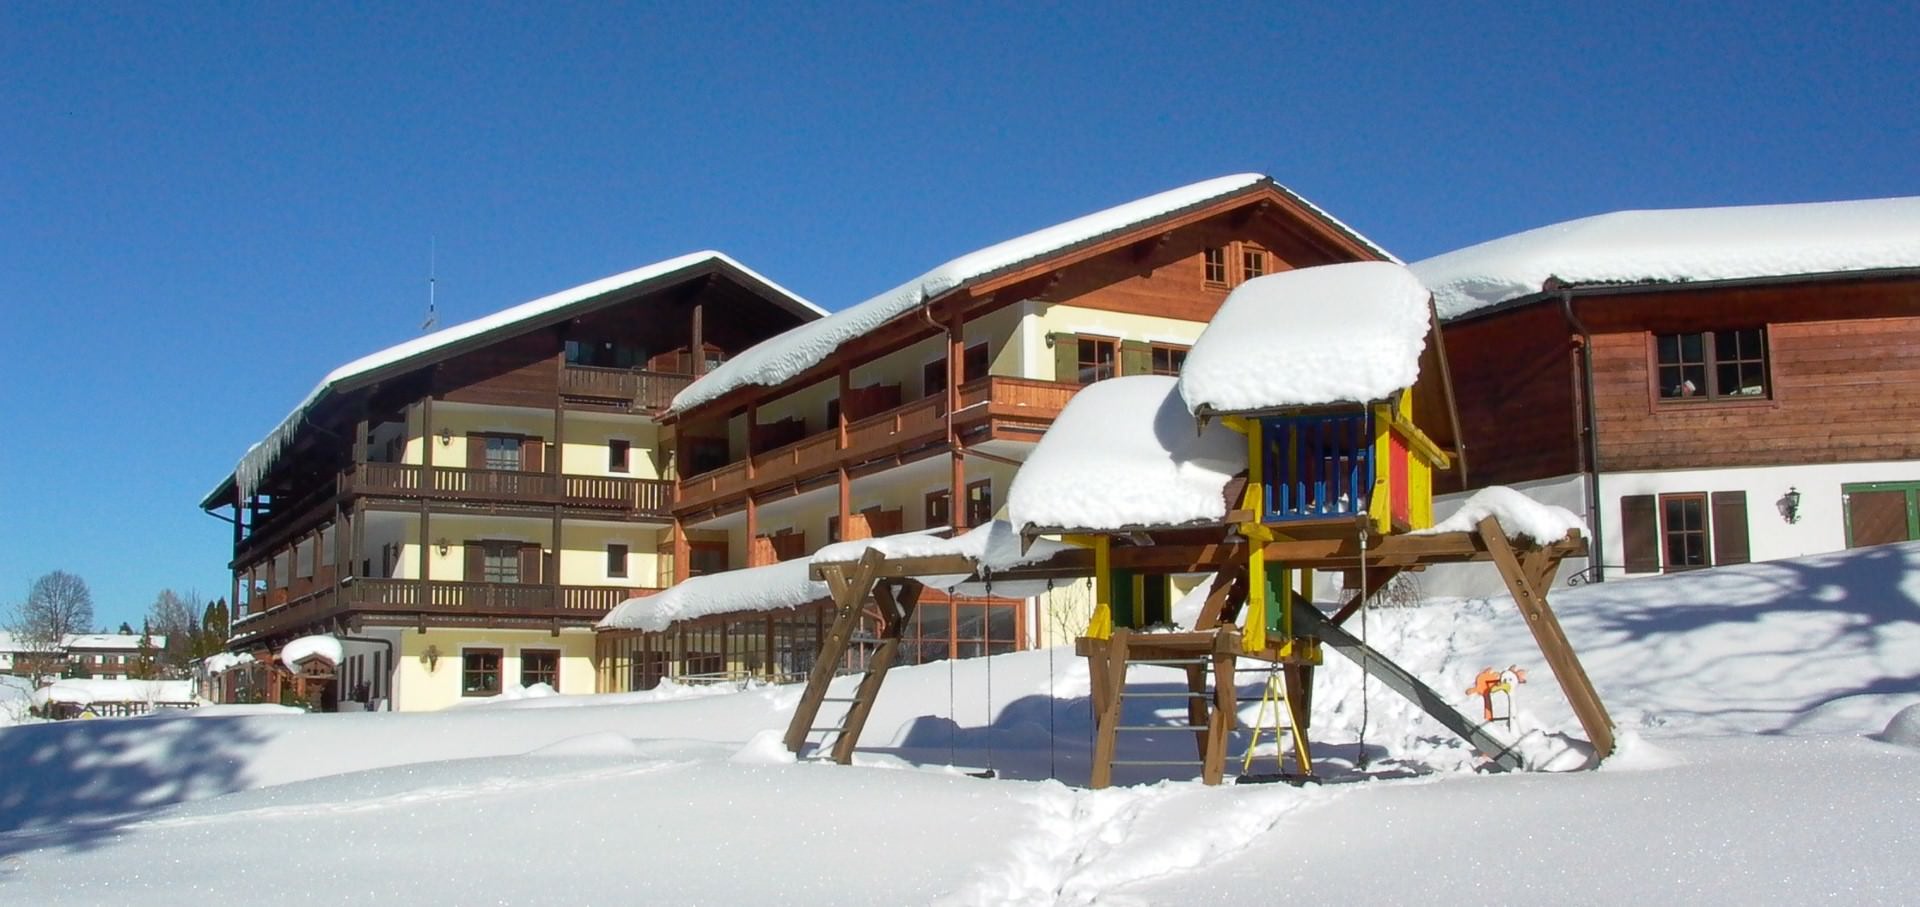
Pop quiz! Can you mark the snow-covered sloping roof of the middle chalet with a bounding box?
[674,173,1392,411]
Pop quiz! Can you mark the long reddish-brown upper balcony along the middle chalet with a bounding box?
[674,377,1079,511]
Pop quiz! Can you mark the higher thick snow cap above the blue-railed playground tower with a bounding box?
[1181,261,1428,413]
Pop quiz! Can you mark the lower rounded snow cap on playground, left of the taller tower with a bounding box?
[1006,375,1246,530]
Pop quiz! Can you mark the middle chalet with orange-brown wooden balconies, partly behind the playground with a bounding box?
[609,175,1390,680]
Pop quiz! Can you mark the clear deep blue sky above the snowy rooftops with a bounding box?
[0,2,1920,625]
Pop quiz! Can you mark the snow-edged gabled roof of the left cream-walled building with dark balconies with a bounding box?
[207,250,826,500]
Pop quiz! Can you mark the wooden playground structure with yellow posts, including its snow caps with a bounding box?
[785,263,1613,788]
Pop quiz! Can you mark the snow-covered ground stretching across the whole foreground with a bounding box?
[0,546,1920,905]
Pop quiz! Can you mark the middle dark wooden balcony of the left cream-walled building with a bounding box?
[342,463,674,519]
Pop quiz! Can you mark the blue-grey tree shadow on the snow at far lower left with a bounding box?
[0,717,265,857]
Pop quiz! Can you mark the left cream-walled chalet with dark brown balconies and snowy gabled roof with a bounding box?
[202,252,822,709]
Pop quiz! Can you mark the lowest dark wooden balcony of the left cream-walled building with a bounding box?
[232,578,659,640]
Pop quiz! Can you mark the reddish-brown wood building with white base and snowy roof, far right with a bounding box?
[1411,198,1920,576]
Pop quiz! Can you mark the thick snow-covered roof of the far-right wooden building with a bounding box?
[1411,196,1920,319]
